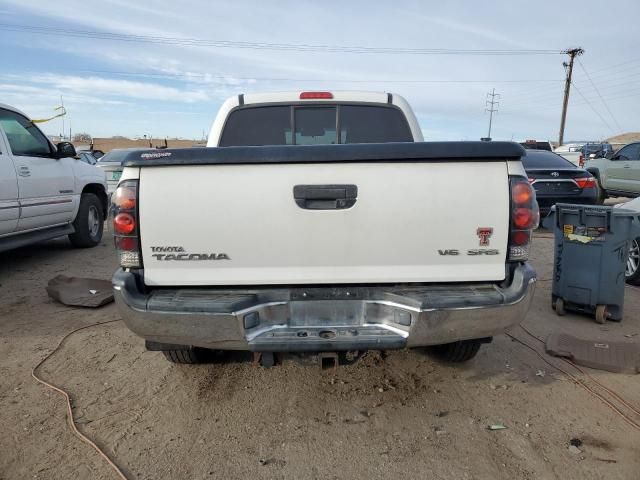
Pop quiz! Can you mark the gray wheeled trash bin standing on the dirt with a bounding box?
[544,203,638,323]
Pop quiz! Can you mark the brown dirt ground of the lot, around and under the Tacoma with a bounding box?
[0,227,640,480]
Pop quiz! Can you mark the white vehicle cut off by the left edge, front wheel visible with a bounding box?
[0,104,108,251]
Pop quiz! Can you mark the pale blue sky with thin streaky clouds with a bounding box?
[0,0,640,140]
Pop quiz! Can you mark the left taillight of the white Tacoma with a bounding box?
[111,180,142,268]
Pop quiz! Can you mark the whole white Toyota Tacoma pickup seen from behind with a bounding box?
[112,92,538,363]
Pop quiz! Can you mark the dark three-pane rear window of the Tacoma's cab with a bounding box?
[220,103,413,147]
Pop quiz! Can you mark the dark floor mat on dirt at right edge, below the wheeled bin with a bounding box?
[546,333,640,373]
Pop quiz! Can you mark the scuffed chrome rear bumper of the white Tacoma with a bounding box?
[113,264,536,352]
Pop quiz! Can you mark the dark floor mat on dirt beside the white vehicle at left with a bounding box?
[47,275,113,308]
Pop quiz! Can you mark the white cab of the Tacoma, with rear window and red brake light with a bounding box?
[207,91,423,147]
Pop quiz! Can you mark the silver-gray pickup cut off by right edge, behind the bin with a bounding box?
[585,142,640,198]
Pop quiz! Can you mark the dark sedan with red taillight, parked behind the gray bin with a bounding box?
[522,150,599,215]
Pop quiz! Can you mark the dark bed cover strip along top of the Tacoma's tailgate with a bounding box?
[122,142,525,167]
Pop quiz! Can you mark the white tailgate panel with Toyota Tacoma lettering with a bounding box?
[139,160,510,286]
